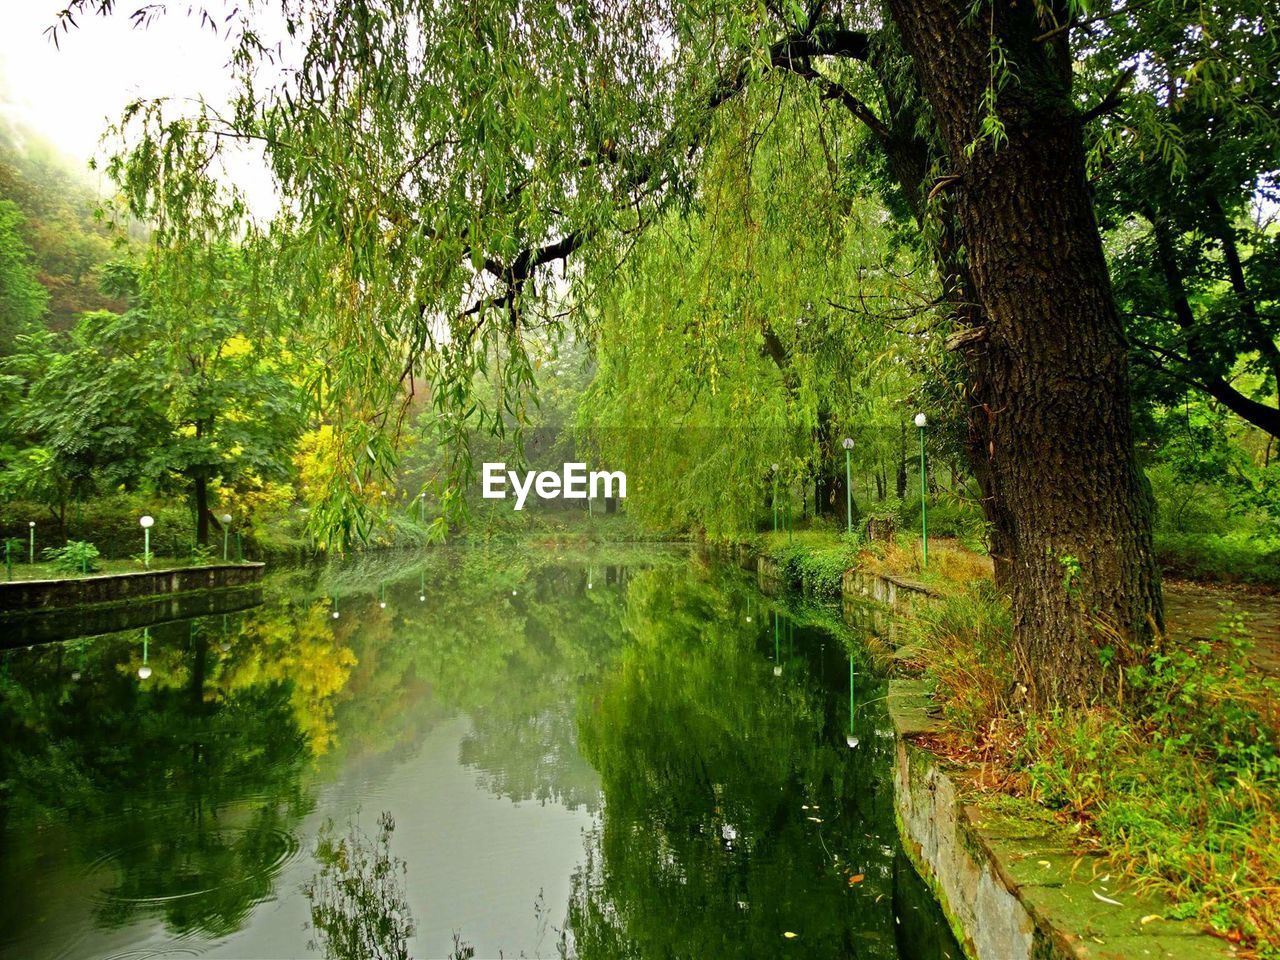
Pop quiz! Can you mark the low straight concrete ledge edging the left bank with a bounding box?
[0,563,264,618]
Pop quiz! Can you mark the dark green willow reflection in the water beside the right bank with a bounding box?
[570,571,937,957]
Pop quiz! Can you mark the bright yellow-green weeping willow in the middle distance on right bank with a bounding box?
[580,82,938,536]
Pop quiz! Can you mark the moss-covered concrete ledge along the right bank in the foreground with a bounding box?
[888,680,1235,960]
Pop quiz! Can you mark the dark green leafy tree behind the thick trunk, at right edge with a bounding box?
[1083,0,1280,436]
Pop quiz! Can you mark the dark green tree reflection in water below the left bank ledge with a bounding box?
[0,611,317,942]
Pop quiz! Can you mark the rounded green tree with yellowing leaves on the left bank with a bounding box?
[14,247,305,544]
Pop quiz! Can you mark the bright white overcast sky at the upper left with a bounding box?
[0,0,274,210]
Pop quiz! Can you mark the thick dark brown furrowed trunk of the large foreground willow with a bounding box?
[890,0,1162,705]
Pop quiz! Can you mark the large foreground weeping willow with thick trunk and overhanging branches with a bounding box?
[54,0,1276,704]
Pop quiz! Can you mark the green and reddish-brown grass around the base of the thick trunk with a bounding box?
[906,584,1280,960]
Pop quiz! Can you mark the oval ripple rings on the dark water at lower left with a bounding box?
[84,827,301,911]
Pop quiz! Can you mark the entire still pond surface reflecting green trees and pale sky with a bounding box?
[0,549,960,960]
